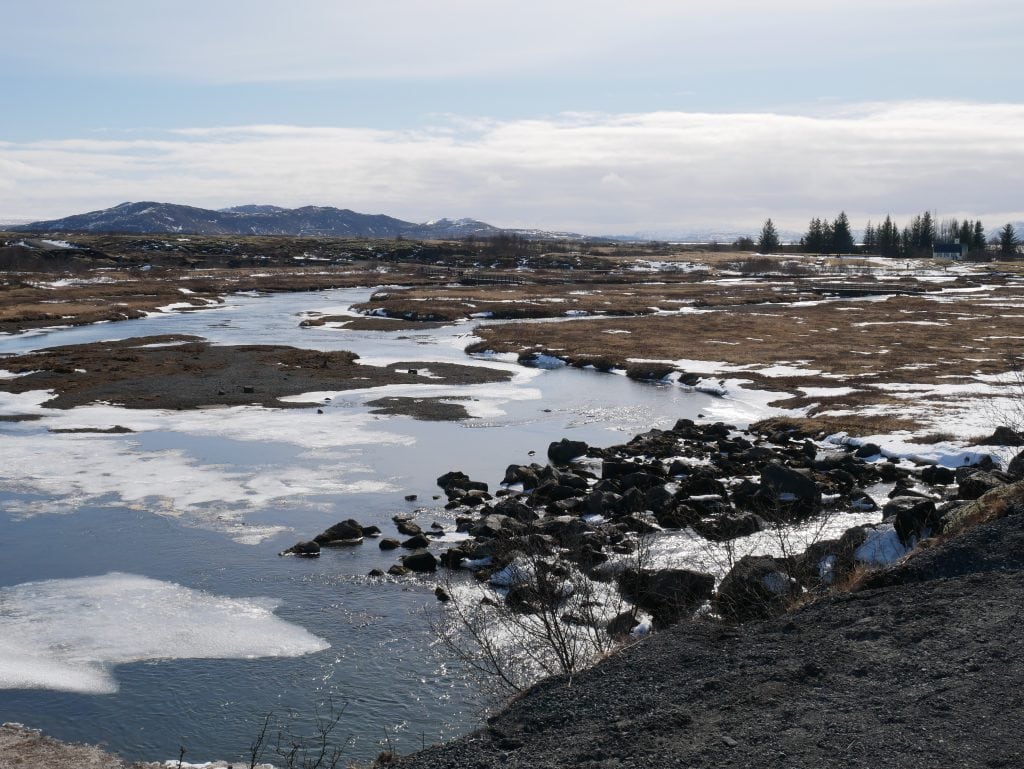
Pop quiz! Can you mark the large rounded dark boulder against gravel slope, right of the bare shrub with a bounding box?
[715,555,800,623]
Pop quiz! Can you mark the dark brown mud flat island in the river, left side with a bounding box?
[0,335,512,411]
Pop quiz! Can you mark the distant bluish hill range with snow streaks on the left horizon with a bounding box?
[12,202,572,240]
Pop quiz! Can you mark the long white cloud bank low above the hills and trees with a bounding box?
[6,102,1024,232]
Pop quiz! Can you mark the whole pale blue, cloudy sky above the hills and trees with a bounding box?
[0,0,1024,237]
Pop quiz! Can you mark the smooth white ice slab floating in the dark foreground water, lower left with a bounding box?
[0,572,330,694]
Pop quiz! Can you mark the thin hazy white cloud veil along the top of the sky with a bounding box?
[0,0,1022,83]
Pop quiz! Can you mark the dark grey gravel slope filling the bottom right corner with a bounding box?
[399,514,1024,769]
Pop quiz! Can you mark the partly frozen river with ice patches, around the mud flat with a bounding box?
[0,289,774,761]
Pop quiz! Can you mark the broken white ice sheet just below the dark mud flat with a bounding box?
[0,391,414,544]
